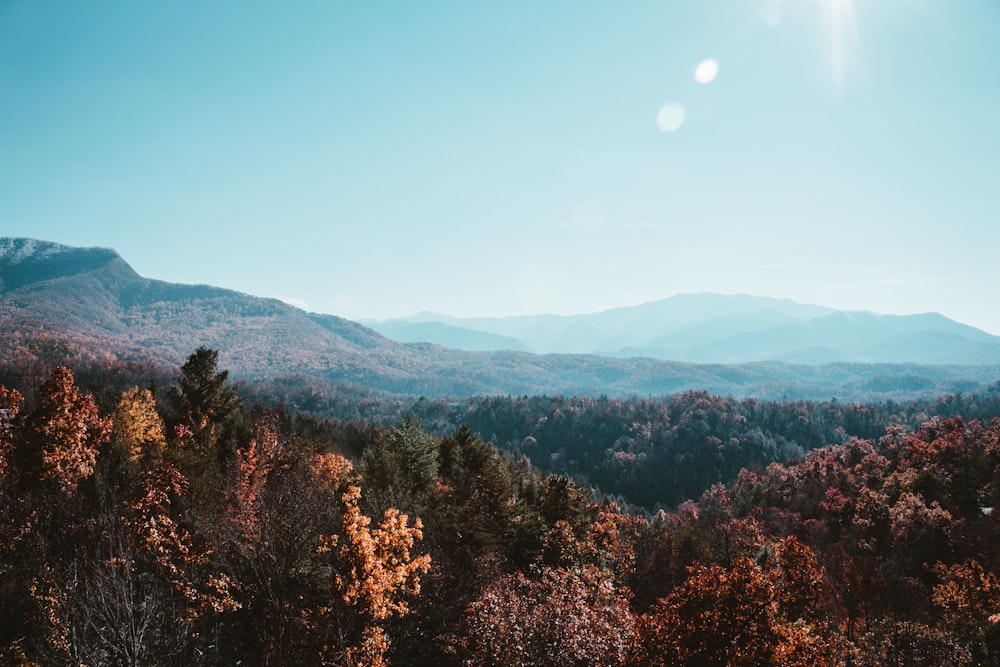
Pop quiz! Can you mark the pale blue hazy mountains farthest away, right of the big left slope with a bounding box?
[370,294,1000,365]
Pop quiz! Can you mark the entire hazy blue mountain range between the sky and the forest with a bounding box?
[0,238,1000,398]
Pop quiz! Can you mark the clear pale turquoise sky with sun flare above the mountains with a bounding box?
[0,0,1000,334]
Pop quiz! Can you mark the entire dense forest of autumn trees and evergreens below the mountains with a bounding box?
[0,345,1000,667]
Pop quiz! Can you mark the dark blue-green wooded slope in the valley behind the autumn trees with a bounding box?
[406,387,1000,510]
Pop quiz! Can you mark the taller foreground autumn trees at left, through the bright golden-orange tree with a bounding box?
[0,349,430,665]
